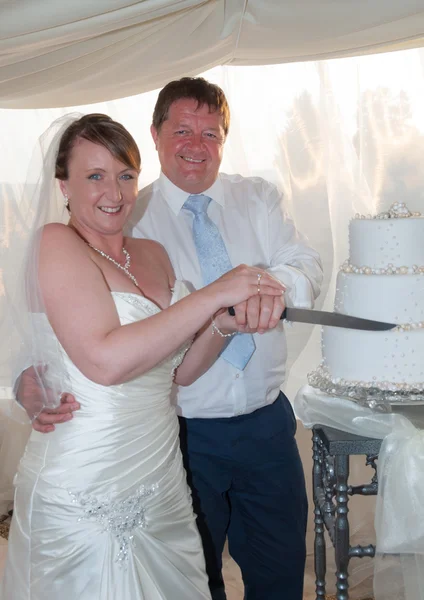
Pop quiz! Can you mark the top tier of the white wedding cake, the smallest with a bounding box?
[349,217,424,269]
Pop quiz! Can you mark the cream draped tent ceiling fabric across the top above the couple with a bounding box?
[0,0,424,108]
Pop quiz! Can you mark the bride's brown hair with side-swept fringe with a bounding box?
[55,113,141,180]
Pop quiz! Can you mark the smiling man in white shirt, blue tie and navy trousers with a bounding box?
[18,78,322,600]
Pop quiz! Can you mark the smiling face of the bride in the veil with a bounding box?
[60,139,138,235]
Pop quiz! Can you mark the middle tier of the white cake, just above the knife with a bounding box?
[334,273,424,326]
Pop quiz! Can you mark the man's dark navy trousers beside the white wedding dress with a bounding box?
[180,393,308,600]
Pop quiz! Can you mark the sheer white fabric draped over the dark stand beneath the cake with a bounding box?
[294,386,424,600]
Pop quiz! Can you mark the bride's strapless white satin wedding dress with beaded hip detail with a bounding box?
[0,282,210,600]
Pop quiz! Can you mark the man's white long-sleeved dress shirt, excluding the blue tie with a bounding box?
[132,173,322,418]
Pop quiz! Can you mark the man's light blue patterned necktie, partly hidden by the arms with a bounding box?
[183,194,256,371]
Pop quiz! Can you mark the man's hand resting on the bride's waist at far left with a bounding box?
[16,367,80,433]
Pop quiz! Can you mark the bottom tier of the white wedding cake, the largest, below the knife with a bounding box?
[322,327,424,390]
